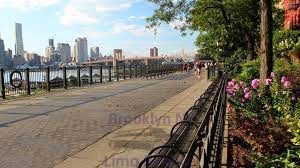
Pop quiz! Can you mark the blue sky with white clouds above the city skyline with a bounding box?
[0,0,196,57]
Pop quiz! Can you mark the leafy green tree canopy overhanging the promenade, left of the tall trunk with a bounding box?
[147,0,260,60]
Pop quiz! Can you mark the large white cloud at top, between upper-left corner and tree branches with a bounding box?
[60,0,141,25]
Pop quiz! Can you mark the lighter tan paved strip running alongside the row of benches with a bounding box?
[55,71,210,168]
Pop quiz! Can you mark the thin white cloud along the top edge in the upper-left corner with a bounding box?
[0,0,61,10]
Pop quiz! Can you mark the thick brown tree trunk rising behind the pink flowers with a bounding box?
[260,0,273,83]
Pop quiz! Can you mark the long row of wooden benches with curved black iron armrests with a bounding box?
[138,73,227,168]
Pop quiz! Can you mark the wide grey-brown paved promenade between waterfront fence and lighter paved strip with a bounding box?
[0,73,207,168]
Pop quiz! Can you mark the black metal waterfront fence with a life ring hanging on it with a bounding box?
[0,64,182,99]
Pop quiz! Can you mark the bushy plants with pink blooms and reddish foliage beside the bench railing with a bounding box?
[226,73,300,167]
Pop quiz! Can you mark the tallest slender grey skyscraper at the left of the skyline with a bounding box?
[15,23,24,57]
